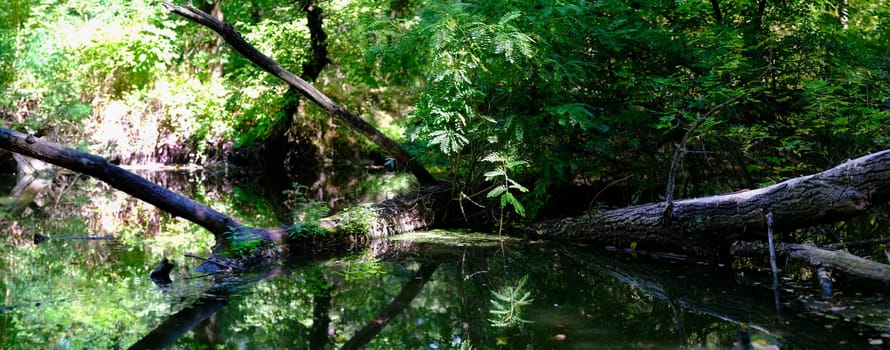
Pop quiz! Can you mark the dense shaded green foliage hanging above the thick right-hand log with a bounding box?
[338,0,890,216]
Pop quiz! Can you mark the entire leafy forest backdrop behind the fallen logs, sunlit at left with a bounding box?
[0,0,890,216]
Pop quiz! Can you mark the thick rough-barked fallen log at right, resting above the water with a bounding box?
[529,150,890,255]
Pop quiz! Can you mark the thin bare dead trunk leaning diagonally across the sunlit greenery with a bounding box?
[164,3,436,185]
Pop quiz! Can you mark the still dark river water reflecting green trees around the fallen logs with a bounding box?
[0,166,890,349]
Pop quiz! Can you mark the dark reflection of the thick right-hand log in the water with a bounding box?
[562,246,880,349]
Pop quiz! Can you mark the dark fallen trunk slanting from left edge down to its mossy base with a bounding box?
[0,128,449,262]
